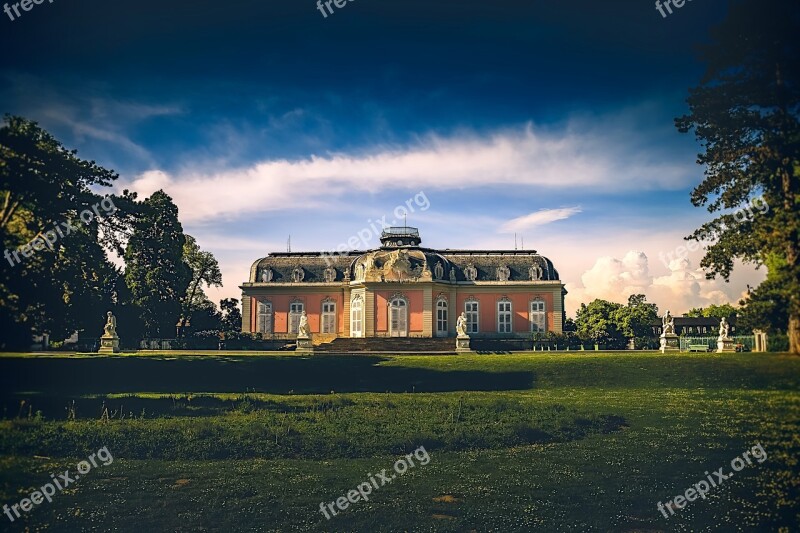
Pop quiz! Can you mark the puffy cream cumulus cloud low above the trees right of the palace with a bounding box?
[567,251,741,314]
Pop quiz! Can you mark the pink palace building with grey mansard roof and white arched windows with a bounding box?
[240,227,566,344]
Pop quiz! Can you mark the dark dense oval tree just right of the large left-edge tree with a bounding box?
[125,191,192,337]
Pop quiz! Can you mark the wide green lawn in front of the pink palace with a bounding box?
[0,352,800,531]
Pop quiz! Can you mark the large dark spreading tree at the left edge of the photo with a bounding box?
[0,115,135,348]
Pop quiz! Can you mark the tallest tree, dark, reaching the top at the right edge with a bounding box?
[676,0,800,354]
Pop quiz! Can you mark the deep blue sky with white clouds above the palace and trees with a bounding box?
[0,0,765,315]
